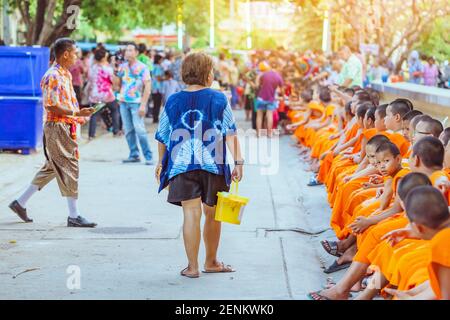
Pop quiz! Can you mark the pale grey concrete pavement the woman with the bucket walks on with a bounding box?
[0,112,342,299]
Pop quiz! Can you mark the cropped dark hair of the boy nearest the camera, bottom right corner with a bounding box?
[405,186,449,229]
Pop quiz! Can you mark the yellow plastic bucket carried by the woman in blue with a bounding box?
[216,182,249,225]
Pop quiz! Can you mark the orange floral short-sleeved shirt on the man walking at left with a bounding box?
[41,63,79,124]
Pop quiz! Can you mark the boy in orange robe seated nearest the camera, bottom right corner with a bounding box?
[386,187,450,300]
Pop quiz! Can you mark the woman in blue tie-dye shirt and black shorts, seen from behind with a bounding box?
[156,53,244,278]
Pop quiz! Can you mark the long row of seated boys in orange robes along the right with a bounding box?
[278,63,450,300]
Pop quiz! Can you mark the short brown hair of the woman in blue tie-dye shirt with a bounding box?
[181,52,213,86]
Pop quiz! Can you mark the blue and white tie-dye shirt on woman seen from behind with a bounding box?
[155,88,236,191]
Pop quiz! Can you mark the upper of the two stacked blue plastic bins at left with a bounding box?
[0,46,50,97]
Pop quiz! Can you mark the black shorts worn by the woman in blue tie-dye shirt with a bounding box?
[167,170,230,207]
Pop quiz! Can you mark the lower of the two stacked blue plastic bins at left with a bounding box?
[0,96,43,154]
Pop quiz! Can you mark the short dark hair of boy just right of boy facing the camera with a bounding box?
[412,137,445,168]
